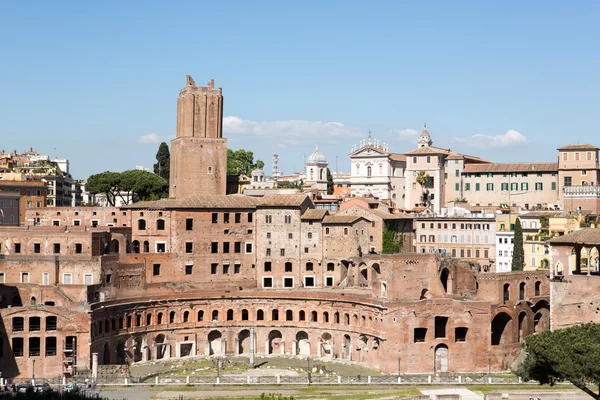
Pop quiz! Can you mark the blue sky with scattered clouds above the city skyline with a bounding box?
[0,0,600,178]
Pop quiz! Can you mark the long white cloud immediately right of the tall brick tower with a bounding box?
[223,116,365,147]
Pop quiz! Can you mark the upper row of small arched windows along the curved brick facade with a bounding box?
[93,308,381,335]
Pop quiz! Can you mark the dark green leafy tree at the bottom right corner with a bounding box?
[516,324,600,399]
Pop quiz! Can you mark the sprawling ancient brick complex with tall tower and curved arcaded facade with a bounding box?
[0,77,550,377]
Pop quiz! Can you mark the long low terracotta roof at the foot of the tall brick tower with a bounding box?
[121,194,259,209]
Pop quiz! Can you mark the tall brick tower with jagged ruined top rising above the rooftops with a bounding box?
[169,75,227,199]
